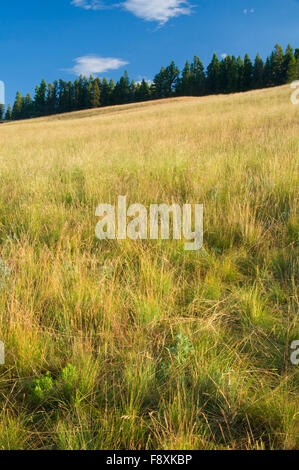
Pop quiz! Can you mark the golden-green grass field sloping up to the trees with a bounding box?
[0,87,299,450]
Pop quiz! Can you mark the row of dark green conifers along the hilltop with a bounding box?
[0,44,299,121]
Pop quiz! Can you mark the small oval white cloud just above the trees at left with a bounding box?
[67,55,129,76]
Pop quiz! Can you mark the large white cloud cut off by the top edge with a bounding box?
[71,0,193,24]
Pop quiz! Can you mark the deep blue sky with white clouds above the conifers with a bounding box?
[0,0,299,103]
